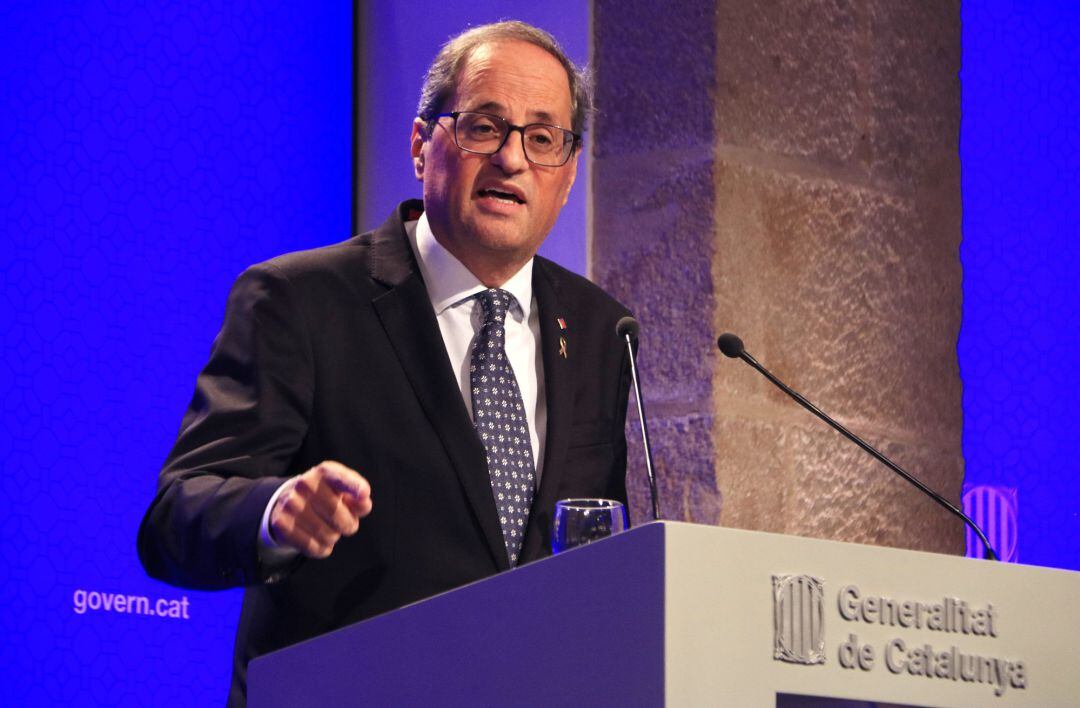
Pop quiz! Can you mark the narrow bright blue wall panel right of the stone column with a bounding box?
[959,0,1080,569]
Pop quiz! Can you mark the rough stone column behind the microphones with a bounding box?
[590,0,963,553]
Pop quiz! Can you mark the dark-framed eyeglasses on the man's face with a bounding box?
[429,111,581,167]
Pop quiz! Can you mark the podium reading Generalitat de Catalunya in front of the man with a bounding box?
[248,521,1080,708]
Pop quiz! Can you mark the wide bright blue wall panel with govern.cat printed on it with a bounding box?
[0,0,352,705]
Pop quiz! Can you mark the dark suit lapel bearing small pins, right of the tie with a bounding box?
[525,258,575,555]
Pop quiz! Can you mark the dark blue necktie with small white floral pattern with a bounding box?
[469,288,535,566]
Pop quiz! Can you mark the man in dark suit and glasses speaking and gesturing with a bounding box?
[138,23,629,704]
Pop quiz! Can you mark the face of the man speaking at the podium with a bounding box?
[411,41,578,285]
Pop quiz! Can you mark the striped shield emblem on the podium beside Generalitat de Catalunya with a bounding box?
[772,575,825,664]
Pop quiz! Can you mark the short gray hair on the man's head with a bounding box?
[416,21,593,135]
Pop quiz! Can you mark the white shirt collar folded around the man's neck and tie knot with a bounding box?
[405,214,532,321]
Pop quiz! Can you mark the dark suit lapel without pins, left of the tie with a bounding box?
[370,202,510,570]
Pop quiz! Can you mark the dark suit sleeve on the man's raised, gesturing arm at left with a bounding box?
[138,264,313,589]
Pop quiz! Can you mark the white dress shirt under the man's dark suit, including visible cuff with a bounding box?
[259,214,548,564]
